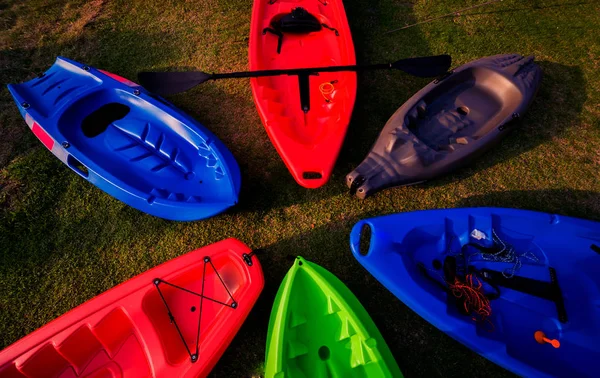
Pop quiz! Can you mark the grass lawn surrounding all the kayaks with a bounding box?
[0,0,600,377]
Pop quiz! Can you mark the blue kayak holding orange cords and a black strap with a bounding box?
[350,208,600,377]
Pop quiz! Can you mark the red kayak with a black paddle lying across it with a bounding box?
[249,0,356,188]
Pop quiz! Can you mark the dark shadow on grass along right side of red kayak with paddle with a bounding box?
[334,0,432,168]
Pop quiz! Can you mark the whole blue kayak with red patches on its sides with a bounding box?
[8,57,241,221]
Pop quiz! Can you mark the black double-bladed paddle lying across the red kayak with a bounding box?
[138,55,452,97]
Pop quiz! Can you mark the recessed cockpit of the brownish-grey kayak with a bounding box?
[387,67,523,153]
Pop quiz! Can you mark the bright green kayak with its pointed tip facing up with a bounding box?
[265,257,402,378]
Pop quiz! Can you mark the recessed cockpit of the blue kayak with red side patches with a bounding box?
[58,89,232,203]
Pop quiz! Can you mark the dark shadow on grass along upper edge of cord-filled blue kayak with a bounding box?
[458,189,600,220]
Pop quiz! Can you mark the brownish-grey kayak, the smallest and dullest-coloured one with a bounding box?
[346,54,542,199]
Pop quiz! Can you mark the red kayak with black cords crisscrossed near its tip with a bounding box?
[0,239,264,378]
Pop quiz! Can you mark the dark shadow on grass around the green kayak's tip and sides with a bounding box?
[211,220,511,377]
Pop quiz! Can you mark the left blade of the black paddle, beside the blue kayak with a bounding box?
[138,71,212,95]
